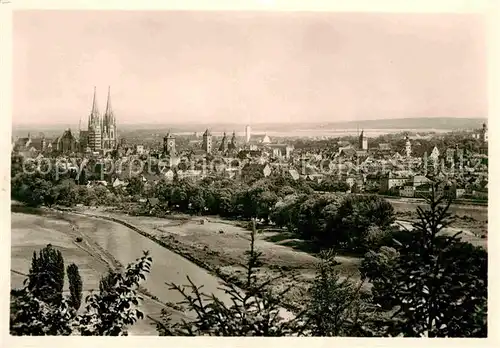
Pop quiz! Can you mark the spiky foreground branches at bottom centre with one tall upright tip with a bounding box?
[157,222,302,336]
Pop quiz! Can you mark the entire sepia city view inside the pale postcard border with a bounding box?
[7,4,491,338]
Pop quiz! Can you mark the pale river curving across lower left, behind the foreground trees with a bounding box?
[11,208,229,335]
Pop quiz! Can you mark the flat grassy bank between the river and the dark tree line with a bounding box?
[68,205,362,309]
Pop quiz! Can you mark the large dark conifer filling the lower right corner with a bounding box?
[364,185,488,337]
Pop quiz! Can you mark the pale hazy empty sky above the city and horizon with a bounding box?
[13,11,487,124]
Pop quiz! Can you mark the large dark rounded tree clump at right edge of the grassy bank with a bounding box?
[270,194,394,252]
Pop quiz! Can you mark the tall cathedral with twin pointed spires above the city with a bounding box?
[80,87,118,152]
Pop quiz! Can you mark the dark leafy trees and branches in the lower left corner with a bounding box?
[10,248,152,336]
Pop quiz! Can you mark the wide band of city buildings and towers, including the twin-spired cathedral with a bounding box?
[12,89,488,199]
